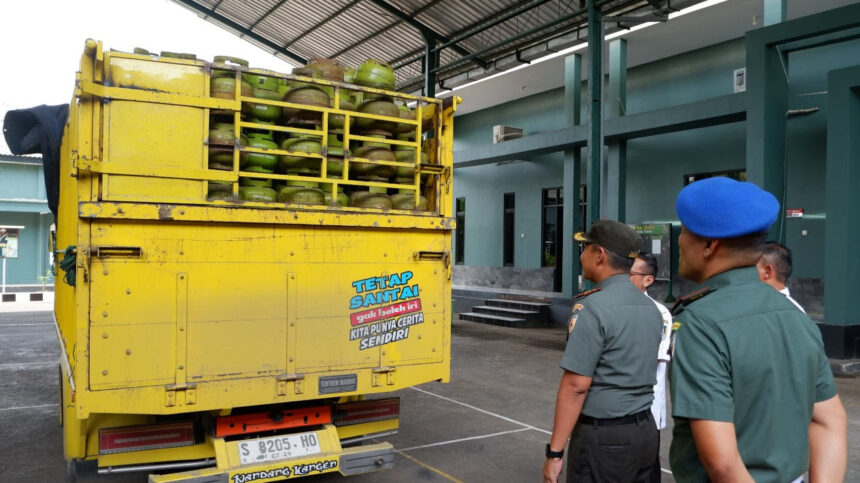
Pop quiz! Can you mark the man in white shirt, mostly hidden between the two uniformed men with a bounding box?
[630,253,672,483]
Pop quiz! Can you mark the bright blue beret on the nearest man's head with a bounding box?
[675,176,779,238]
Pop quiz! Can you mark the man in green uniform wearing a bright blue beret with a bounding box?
[670,177,847,482]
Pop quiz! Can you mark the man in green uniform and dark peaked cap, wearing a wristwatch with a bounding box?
[544,220,663,483]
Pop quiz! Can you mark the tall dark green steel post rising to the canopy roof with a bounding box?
[586,0,603,227]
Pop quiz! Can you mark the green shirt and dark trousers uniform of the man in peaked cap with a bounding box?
[561,273,663,482]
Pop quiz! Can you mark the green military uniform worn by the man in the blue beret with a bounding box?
[670,267,836,482]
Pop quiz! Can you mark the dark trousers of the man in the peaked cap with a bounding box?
[567,411,660,483]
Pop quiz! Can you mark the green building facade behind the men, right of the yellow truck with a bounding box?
[454,5,860,357]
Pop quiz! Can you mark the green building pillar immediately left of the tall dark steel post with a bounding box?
[561,54,582,297]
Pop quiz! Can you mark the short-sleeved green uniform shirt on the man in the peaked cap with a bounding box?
[561,273,663,418]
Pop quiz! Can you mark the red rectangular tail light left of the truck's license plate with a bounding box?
[99,421,194,454]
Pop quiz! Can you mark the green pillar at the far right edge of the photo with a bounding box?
[819,67,860,359]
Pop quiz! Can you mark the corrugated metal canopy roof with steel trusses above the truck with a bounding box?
[168,0,703,92]
